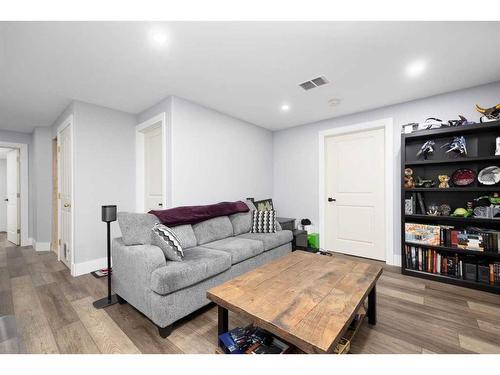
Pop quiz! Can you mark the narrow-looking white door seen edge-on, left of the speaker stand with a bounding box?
[57,126,73,267]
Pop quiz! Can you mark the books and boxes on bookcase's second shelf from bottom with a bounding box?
[405,223,500,253]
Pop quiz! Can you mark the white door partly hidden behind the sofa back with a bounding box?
[144,126,163,212]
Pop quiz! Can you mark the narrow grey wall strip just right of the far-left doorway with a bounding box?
[31,127,52,250]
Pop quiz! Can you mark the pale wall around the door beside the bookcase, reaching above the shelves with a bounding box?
[273,82,500,260]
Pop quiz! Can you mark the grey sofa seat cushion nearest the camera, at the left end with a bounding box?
[151,247,231,295]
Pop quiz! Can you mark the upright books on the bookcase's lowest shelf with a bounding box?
[404,245,500,285]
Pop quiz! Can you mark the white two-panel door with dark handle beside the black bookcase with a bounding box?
[324,129,386,260]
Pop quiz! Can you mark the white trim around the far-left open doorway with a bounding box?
[0,142,31,246]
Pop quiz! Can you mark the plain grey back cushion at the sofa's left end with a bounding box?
[117,212,159,246]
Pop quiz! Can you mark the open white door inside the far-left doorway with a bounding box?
[7,149,21,245]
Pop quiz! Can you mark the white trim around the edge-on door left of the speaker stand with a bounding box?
[57,115,76,276]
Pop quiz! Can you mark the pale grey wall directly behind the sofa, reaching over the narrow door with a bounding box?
[138,97,273,206]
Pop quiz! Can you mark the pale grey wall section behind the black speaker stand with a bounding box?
[73,102,137,272]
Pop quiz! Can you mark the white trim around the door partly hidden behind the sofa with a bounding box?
[135,112,172,212]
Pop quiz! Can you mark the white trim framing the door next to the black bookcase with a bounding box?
[318,118,397,265]
